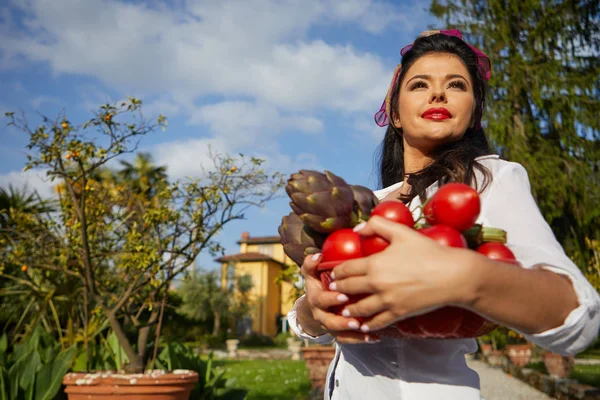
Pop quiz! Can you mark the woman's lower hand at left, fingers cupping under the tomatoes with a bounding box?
[297,254,377,343]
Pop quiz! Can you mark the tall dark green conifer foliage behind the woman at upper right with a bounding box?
[430,0,600,266]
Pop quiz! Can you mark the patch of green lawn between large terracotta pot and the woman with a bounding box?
[213,360,311,400]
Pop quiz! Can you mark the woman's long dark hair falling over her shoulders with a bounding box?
[379,34,491,202]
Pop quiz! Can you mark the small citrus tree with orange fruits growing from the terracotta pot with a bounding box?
[0,98,283,398]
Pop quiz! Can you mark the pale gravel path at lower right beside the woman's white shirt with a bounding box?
[467,359,552,400]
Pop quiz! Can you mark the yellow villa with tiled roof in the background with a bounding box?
[216,232,297,337]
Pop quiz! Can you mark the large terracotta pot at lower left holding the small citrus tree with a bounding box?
[63,370,198,400]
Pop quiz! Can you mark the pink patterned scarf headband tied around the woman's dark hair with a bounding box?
[375,29,492,126]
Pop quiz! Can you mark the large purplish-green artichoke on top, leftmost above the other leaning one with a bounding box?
[285,170,358,233]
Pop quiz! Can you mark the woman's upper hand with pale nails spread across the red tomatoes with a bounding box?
[329,216,475,332]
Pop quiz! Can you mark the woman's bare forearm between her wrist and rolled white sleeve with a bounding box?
[465,253,578,334]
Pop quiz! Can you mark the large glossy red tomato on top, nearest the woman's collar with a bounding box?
[425,183,481,232]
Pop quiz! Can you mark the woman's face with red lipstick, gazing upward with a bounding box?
[392,53,475,153]
